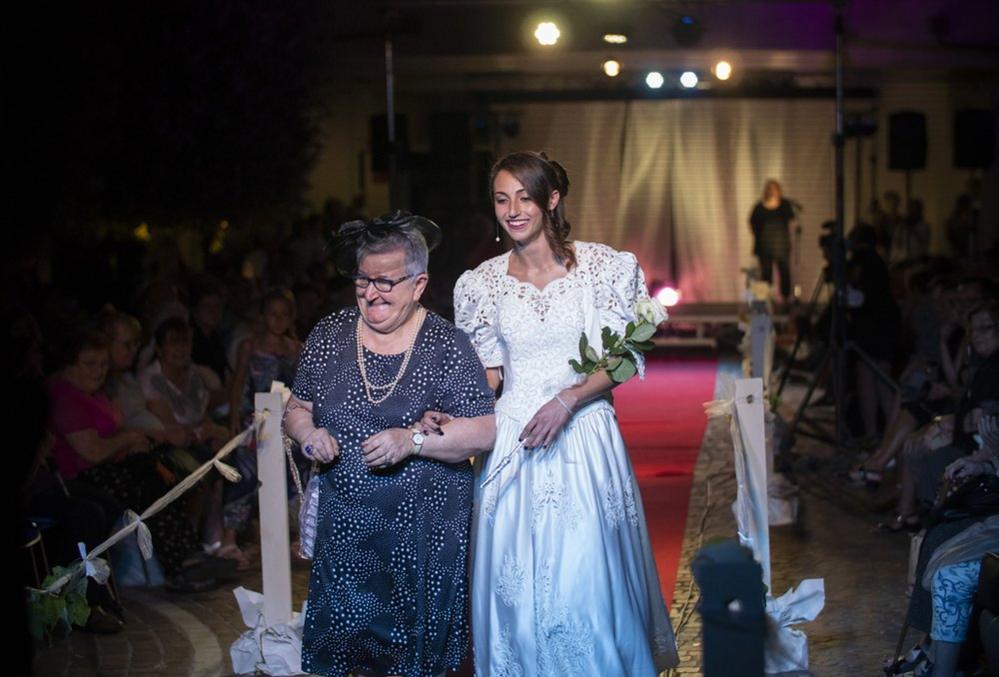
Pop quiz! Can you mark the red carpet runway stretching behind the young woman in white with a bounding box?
[614,357,718,602]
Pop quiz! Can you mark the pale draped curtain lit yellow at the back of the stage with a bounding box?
[496,99,834,302]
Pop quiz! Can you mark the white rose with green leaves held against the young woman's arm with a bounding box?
[569,298,669,383]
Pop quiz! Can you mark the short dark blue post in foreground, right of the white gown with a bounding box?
[690,540,766,677]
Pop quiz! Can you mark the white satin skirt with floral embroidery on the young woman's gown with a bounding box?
[472,401,677,677]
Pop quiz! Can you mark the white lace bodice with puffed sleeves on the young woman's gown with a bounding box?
[454,242,648,423]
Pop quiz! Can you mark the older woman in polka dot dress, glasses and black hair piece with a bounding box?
[285,212,495,677]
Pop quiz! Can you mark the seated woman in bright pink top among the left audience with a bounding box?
[48,330,231,590]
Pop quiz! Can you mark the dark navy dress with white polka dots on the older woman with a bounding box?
[292,309,493,677]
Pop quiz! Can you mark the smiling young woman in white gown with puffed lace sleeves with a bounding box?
[424,153,677,677]
